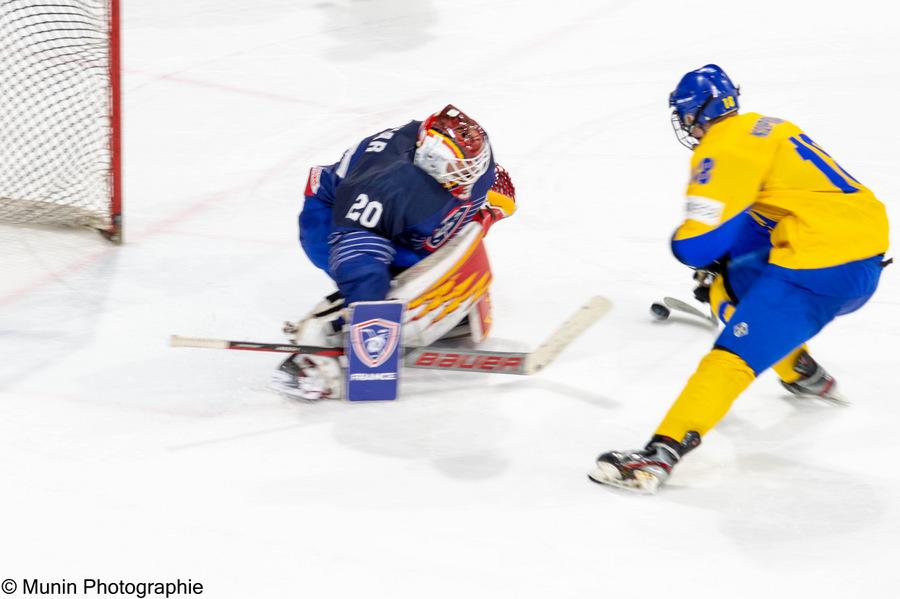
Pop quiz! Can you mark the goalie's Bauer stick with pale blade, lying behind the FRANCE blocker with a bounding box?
[169,296,612,375]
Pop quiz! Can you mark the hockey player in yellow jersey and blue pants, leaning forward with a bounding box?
[589,64,888,493]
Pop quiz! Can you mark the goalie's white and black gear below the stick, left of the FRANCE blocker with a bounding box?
[271,354,343,401]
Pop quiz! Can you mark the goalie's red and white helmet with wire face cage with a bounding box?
[413,104,491,200]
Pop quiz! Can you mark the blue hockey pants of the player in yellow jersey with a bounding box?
[716,248,882,374]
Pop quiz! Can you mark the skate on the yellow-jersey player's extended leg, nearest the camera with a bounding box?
[588,431,700,495]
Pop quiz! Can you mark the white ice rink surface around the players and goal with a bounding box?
[0,0,900,599]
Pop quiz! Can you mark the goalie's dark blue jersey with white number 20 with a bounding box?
[300,121,495,303]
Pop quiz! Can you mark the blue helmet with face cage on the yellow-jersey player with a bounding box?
[669,64,741,150]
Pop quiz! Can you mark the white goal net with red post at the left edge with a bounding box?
[0,0,122,242]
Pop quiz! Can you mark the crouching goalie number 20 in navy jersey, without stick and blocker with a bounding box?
[274,105,516,399]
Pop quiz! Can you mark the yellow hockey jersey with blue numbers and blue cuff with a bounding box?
[672,112,888,269]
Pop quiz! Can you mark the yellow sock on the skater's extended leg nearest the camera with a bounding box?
[656,349,756,441]
